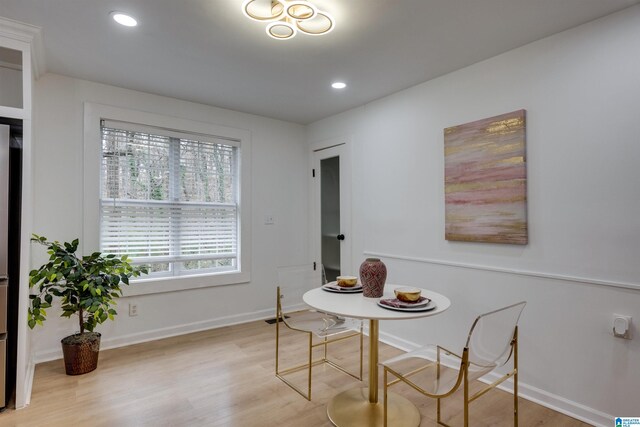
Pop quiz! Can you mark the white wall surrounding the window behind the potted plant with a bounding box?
[33,74,309,361]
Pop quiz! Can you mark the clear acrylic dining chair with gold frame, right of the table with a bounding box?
[381,301,526,427]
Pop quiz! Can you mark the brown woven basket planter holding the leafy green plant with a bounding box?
[61,332,100,375]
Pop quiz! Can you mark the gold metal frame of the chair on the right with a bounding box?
[383,303,522,427]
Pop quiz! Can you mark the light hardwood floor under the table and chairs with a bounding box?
[0,321,588,427]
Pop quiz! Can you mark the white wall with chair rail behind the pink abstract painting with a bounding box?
[308,6,640,425]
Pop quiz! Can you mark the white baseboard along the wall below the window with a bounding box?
[34,309,274,363]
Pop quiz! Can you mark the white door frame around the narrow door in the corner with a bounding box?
[309,136,357,277]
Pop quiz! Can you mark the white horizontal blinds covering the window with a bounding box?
[100,120,239,276]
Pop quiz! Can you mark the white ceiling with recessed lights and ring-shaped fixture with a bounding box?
[0,0,640,124]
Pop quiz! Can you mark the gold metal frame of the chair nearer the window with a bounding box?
[276,286,363,401]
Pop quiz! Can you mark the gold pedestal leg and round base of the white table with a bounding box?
[327,319,420,427]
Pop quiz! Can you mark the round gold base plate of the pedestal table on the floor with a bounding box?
[327,388,420,427]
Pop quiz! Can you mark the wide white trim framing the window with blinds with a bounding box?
[81,102,251,296]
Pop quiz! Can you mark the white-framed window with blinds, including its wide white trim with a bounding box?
[80,102,251,296]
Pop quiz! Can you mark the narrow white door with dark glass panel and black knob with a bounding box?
[312,142,357,281]
